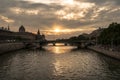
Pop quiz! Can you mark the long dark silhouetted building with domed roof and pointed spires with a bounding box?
[0,25,45,41]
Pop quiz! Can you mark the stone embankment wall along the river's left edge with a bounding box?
[0,43,25,54]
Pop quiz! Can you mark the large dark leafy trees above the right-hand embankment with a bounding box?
[98,22,120,46]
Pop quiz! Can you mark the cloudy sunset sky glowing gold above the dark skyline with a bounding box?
[0,0,120,39]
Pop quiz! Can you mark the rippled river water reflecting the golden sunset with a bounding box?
[0,46,120,80]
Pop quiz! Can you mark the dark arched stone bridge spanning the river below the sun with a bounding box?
[24,40,90,48]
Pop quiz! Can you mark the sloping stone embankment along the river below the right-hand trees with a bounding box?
[88,46,120,60]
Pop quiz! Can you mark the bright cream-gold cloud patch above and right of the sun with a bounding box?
[56,3,95,20]
